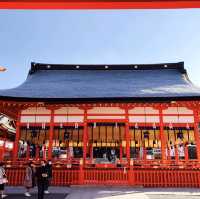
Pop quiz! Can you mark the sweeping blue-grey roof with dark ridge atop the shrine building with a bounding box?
[0,62,200,101]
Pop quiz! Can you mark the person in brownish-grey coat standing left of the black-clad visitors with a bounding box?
[24,162,34,197]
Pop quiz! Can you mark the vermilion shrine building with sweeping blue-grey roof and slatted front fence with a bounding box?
[0,62,200,187]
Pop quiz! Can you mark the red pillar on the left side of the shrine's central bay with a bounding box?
[83,109,88,165]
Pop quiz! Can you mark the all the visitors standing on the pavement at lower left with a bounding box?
[0,160,52,199]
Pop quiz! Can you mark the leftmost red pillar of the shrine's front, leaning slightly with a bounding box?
[13,110,21,161]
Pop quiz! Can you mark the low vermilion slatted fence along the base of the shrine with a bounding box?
[6,168,200,187]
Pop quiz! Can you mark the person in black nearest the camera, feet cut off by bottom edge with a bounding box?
[36,160,48,199]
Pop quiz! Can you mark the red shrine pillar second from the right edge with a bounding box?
[159,107,166,163]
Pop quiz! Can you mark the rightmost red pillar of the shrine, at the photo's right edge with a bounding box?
[193,109,200,163]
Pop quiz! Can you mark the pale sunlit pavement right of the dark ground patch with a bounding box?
[67,186,200,199]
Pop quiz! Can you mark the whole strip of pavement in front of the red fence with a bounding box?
[6,186,200,199]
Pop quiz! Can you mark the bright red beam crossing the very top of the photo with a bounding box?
[0,0,200,10]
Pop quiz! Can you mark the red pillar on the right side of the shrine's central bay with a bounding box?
[125,109,130,165]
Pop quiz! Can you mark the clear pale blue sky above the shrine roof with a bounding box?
[0,9,200,89]
